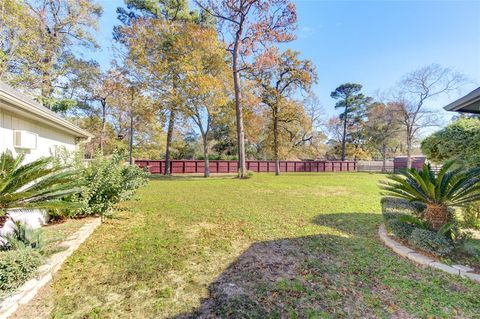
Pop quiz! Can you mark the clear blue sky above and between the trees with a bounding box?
[91,0,480,124]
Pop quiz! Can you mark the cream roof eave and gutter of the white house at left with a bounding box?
[0,82,93,138]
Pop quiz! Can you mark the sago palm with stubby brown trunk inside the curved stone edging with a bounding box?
[380,162,480,230]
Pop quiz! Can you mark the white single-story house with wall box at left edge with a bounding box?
[0,82,93,162]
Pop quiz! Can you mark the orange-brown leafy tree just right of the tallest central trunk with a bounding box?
[252,50,317,175]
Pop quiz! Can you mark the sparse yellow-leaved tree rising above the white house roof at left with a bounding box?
[0,0,102,106]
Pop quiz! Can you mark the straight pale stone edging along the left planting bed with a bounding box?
[0,217,101,319]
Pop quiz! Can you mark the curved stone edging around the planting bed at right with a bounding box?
[378,224,480,283]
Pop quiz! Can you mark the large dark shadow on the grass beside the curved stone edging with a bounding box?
[167,213,478,319]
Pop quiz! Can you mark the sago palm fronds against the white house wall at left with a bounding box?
[0,151,81,216]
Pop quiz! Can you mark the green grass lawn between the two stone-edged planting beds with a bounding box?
[47,173,480,318]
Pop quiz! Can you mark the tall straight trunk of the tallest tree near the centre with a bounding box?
[232,30,246,178]
